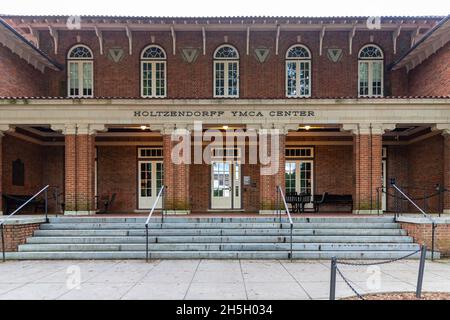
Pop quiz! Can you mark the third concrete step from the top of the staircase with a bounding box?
[35,229,406,236]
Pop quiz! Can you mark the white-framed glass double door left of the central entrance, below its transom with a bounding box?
[138,161,164,209]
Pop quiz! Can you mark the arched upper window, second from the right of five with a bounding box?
[286,45,311,97]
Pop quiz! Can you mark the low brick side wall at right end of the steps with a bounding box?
[401,222,450,257]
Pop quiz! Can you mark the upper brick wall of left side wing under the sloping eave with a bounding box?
[0,45,48,97]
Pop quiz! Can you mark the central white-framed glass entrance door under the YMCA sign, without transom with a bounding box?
[211,161,241,209]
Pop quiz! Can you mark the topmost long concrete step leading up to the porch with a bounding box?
[50,214,394,224]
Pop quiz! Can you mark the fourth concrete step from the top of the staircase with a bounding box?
[27,235,413,243]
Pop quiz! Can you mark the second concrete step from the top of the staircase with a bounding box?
[41,222,400,230]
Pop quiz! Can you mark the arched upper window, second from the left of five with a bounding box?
[141,45,167,98]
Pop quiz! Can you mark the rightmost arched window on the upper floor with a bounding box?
[358,44,384,97]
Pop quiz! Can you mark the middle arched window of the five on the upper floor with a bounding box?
[214,45,239,97]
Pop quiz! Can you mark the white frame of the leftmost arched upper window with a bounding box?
[67,44,94,98]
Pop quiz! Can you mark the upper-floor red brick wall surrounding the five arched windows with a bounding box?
[35,31,410,98]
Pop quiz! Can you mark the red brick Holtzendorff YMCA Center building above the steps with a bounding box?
[0,16,450,215]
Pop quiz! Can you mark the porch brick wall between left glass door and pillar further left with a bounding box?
[97,146,138,212]
